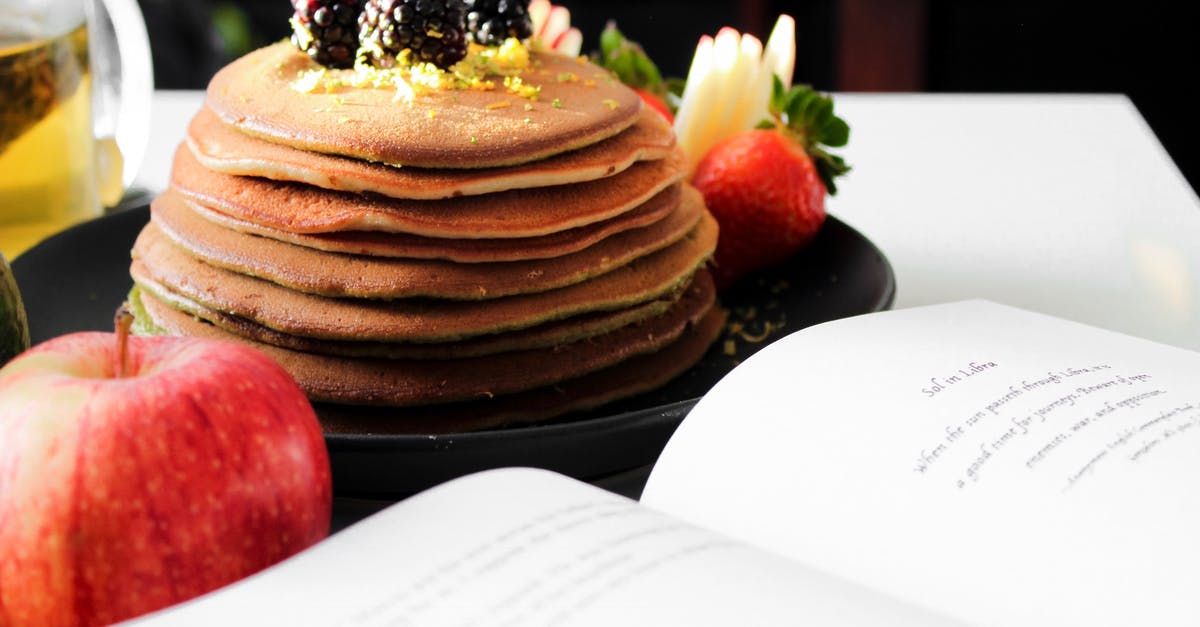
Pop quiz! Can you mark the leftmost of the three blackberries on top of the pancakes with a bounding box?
[292,0,360,68]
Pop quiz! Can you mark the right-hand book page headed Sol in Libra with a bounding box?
[642,301,1200,626]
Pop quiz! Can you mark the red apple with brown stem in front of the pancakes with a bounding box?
[0,314,332,627]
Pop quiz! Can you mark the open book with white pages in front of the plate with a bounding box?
[129,301,1200,626]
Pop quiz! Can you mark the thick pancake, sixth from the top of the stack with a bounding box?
[130,211,716,342]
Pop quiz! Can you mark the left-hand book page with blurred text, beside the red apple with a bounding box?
[126,468,947,627]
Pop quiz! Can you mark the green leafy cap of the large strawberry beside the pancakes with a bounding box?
[758,76,850,196]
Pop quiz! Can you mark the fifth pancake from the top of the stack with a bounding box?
[152,186,704,300]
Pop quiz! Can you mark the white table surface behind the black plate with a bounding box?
[137,91,1200,350]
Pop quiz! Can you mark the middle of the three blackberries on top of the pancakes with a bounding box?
[359,0,467,70]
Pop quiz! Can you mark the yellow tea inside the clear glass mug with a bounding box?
[0,24,100,259]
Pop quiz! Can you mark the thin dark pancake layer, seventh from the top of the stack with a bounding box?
[130,281,686,359]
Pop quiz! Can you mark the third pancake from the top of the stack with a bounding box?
[170,141,685,239]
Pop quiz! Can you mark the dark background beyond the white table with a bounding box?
[140,0,1200,189]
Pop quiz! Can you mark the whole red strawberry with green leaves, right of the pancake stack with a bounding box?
[691,77,850,288]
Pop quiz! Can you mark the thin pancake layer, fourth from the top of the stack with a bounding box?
[166,185,682,263]
